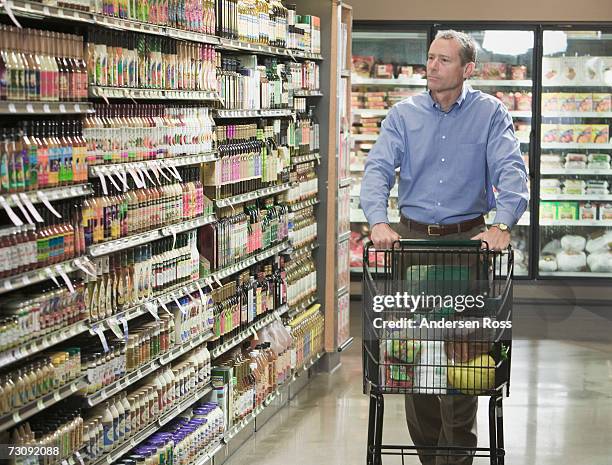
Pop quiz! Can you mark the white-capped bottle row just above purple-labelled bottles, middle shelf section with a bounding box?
[84,349,211,460]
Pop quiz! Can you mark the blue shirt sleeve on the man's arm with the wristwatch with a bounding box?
[487,105,529,227]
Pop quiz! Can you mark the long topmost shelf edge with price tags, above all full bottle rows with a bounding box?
[1,0,323,61]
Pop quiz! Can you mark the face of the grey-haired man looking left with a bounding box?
[427,39,473,92]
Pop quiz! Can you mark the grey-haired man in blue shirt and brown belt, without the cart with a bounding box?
[360,30,529,465]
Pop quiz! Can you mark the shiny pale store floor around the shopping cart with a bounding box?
[226,302,612,465]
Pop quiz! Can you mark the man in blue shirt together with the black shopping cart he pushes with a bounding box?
[360,31,529,465]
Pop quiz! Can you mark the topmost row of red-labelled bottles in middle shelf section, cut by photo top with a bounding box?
[91,0,216,35]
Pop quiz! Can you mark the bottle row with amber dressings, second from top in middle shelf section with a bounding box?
[86,29,217,91]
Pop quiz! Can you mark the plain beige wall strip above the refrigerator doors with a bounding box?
[348,0,612,22]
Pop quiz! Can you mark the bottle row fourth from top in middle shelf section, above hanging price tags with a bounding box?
[81,168,207,246]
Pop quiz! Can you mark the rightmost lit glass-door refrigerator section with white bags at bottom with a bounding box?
[538,29,612,278]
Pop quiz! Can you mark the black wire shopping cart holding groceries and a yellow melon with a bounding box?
[363,240,513,465]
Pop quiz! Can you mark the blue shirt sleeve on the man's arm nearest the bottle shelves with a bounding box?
[359,107,407,227]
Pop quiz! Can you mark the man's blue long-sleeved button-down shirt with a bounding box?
[360,85,529,226]
